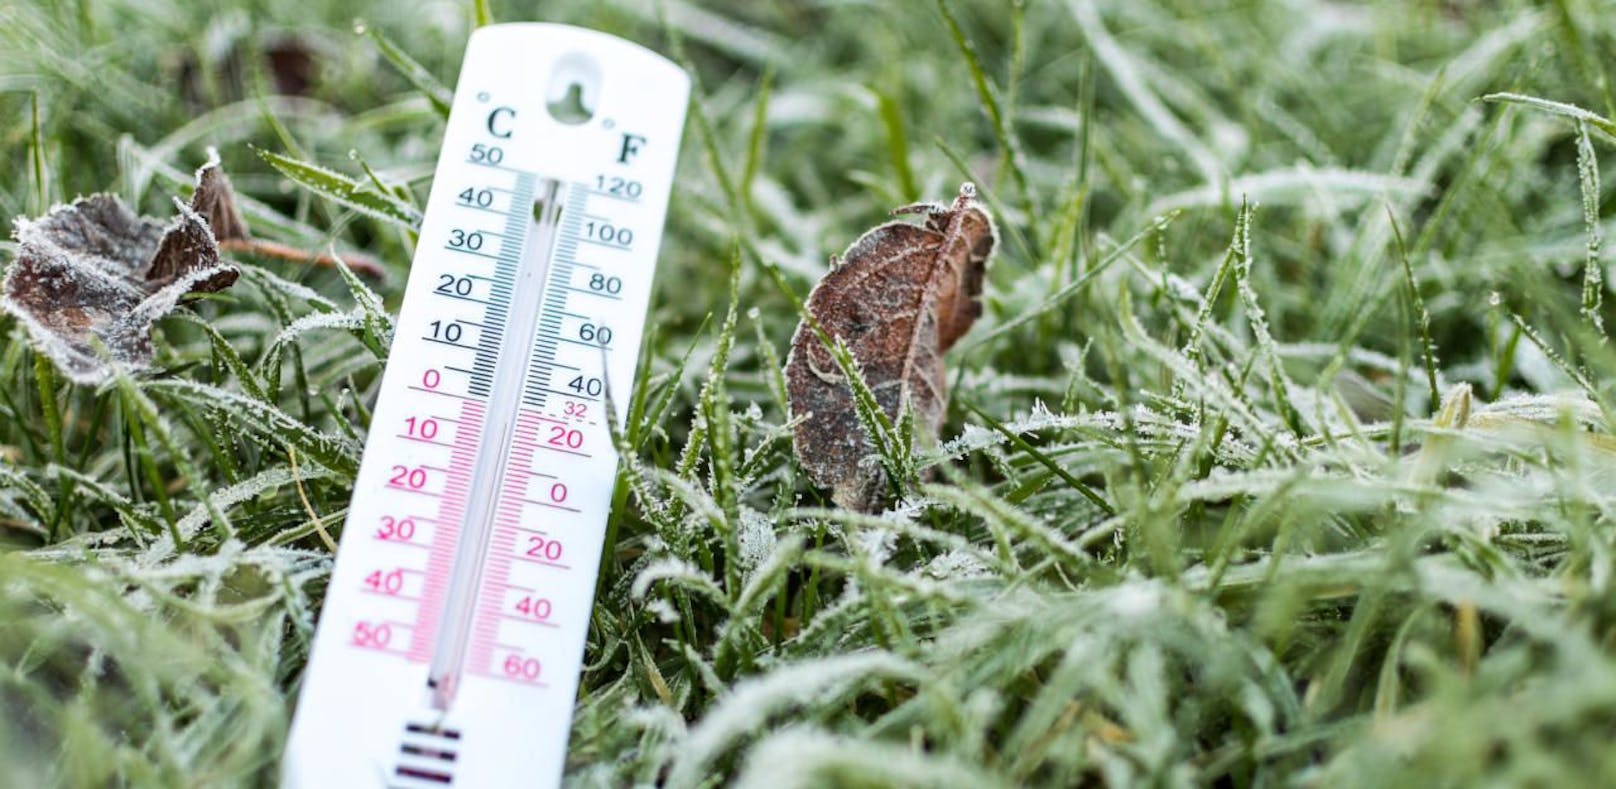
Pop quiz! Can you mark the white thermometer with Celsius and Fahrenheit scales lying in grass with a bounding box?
[283,24,690,789]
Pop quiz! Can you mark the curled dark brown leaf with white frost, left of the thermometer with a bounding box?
[0,162,239,383]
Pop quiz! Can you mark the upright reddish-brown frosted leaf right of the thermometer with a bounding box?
[785,184,995,511]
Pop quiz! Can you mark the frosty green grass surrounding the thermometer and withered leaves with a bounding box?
[0,0,1616,787]
